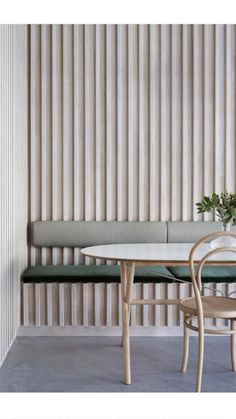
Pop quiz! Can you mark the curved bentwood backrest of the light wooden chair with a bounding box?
[189,231,236,311]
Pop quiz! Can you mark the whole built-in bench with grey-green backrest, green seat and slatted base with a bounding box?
[19,221,236,334]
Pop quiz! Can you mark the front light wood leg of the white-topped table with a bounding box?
[121,262,135,384]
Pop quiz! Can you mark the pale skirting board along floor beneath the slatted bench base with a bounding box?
[17,326,230,337]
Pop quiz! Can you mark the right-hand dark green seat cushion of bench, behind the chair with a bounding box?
[168,266,236,283]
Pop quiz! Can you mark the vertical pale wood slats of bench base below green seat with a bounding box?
[22,283,236,330]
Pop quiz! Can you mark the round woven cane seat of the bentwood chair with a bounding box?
[180,297,236,319]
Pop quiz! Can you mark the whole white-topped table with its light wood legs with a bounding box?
[81,243,235,384]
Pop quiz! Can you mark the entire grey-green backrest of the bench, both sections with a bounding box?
[31,221,232,247]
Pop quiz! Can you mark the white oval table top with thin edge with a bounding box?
[81,243,236,264]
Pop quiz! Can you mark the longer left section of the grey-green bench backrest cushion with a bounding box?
[31,221,167,247]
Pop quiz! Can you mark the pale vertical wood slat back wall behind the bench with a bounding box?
[26,25,236,332]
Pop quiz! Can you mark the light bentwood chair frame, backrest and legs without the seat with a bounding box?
[180,231,236,392]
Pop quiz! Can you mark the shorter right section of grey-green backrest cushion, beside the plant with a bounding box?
[167,221,230,243]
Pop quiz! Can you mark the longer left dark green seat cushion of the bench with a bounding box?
[22,265,175,283]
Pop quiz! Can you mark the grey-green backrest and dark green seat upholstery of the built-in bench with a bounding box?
[22,221,236,283]
